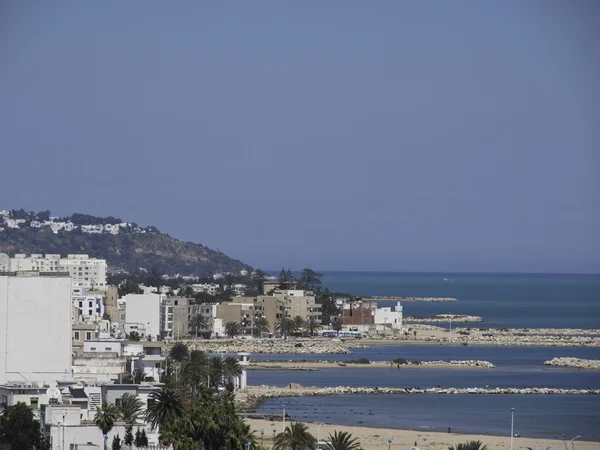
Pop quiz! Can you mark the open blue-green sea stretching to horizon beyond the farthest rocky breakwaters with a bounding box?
[323,272,600,328]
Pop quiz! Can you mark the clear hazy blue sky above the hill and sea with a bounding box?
[0,0,600,272]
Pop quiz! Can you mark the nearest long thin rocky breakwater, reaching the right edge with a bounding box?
[236,383,600,407]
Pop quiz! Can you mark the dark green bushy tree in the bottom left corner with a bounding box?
[0,402,49,450]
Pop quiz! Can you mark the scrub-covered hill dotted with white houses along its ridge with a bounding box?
[0,209,251,275]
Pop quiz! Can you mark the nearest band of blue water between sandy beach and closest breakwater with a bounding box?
[257,395,600,438]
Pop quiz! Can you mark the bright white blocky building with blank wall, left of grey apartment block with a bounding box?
[122,294,173,340]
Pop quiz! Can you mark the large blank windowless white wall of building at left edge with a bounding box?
[0,272,72,385]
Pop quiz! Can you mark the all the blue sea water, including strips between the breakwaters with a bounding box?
[253,272,600,442]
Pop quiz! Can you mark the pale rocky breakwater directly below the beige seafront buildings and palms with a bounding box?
[189,339,366,354]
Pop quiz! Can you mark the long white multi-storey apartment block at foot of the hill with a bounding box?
[3,253,108,295]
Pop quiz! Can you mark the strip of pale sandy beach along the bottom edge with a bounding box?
[246,419,600,450]
